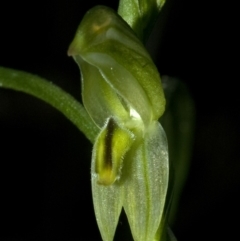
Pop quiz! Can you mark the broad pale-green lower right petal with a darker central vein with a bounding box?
[123,122,169,241]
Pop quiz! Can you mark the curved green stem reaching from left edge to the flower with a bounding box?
[0,67,99,143]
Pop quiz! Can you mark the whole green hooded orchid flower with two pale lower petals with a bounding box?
[68,6,169,241]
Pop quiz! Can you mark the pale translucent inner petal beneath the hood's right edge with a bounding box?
[81,53,152,125]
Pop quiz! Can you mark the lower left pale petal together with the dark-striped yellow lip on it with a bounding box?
[91,118,134,241]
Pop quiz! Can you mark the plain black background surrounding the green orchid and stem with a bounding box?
[0,0,237,241]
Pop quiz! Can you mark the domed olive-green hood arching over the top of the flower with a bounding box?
[68,6,165,126]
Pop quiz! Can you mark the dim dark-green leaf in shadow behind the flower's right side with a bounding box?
[161,76,196,225]
